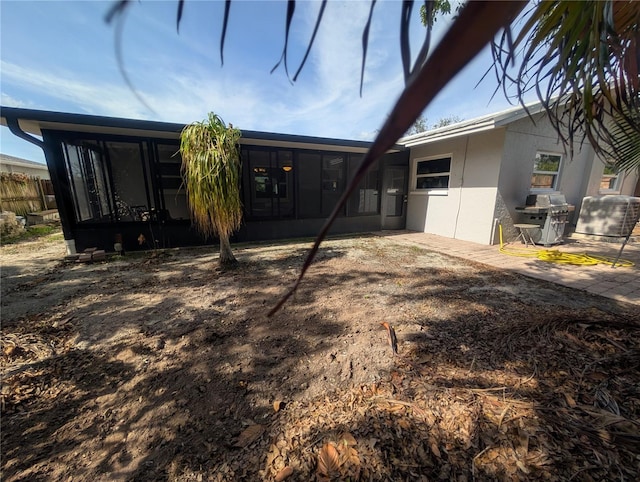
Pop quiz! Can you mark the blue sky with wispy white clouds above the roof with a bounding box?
[0,0,528,162]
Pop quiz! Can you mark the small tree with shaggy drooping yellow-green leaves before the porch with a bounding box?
[180,112,242,266]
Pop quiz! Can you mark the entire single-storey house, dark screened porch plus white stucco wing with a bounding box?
[0,105,638,252]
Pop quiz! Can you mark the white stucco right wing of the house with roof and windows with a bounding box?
[399,104,638,244]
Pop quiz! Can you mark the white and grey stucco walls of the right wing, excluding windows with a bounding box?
[407,110,638,244]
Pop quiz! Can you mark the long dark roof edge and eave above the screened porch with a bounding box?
[0,107,405,153]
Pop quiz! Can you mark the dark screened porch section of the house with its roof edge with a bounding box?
[2,108,408,253]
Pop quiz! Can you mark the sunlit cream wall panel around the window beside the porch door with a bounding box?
[407,128,505,244]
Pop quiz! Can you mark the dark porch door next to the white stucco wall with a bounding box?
[382,166,409,229]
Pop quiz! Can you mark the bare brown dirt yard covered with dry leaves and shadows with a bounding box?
[0,231,640,482]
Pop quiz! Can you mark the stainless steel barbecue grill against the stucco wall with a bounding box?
[516,193,575,246]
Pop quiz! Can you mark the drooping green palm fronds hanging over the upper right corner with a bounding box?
[492,0,640,166]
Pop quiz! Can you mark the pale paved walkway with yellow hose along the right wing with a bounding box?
[380,231,640,306]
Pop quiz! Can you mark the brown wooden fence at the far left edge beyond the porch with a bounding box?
[0,172,53,216]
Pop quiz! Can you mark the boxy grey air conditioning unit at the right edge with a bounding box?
[576,195,640,237]
